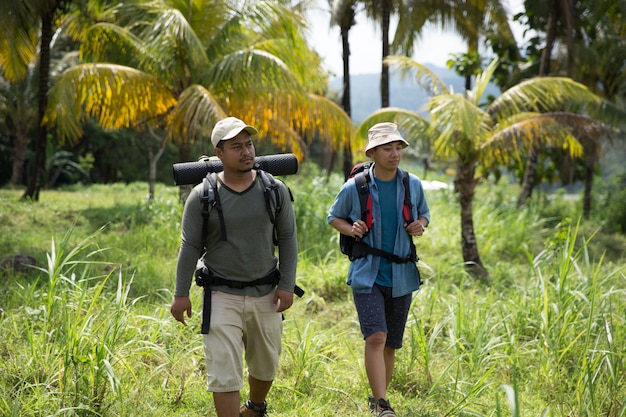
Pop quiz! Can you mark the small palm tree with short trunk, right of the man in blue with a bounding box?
[357,56,620,277]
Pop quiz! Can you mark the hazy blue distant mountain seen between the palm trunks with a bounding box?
[329,65,500,124]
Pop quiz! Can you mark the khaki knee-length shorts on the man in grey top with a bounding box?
[203,291,283,392]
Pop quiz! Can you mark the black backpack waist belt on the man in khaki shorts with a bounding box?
[196,267,304,334]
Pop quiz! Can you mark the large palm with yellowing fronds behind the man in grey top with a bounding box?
[47,1,353,198]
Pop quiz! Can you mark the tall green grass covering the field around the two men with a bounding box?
[0,166,626,417]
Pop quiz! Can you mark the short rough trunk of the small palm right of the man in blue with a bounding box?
[454,161,489,278]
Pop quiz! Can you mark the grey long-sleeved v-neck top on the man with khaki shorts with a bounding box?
[174,171,298,296]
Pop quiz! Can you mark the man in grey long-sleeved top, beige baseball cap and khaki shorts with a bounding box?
[171,117,298,417]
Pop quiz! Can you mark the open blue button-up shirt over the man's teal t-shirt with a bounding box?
[327,166,430,297]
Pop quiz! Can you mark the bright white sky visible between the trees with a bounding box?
[307,0,524,77]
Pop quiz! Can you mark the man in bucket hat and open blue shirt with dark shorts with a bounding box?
[327,123,430,417]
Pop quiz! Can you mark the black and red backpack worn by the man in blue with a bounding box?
[339,162,419,263]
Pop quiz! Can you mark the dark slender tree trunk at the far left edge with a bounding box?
[22,8,55,201]
